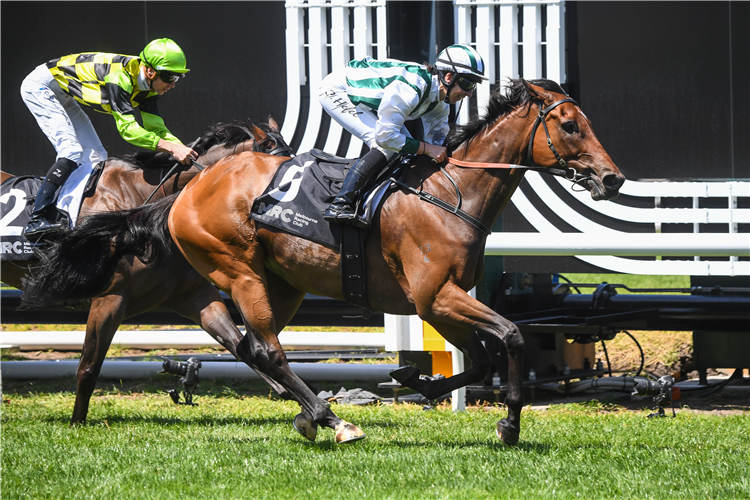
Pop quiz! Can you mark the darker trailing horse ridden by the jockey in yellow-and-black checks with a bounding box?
[5,118,291,424]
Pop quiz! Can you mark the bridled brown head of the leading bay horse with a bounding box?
[522,80,625,200]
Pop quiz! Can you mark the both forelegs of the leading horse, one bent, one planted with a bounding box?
[417,283,525,445]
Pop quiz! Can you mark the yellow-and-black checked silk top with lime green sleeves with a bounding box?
[47,53,181,149]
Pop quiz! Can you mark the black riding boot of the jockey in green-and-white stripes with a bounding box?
[323,149,388,224]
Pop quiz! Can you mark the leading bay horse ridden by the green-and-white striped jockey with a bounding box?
[27,79,625,445]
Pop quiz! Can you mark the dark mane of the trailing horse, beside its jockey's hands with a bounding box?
[114,122,260,168]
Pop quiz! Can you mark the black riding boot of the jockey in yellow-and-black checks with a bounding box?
[24,158,78,241]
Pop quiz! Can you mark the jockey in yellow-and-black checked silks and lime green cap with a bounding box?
[21,38,198,239]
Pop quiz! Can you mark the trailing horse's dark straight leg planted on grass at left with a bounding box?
[70,295,125,425]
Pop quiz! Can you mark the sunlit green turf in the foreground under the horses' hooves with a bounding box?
[0,388,750,500]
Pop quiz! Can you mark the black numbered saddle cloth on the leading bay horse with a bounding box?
[250,150,390,250]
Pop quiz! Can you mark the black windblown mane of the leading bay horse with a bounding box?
[446,78,566,153]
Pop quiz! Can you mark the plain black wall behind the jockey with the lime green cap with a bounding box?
[0,0,286,175]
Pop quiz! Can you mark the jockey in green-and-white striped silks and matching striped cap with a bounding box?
[318,44,487,227]
